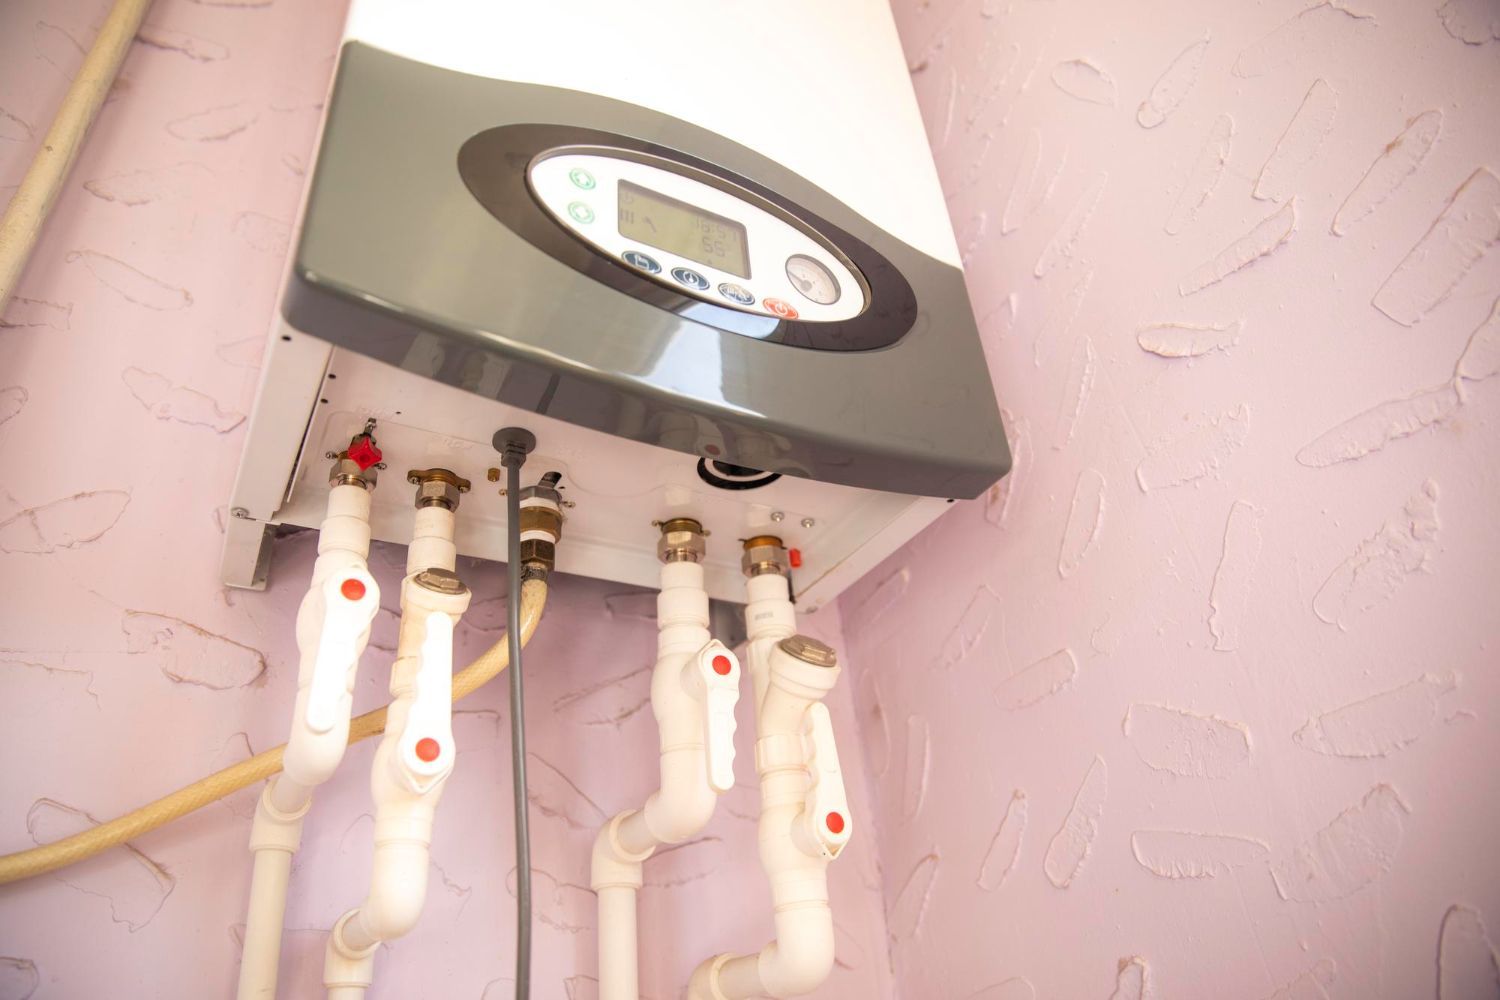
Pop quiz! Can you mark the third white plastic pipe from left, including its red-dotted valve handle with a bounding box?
[590,562,740,1000]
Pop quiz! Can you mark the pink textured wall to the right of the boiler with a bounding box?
[842,0,1500,1000]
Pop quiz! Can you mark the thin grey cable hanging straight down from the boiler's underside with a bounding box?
[501,448,531,1000]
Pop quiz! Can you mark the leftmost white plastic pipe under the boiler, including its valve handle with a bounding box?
[237,484,380,1000]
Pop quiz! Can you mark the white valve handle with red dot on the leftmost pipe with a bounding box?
[306,567,380,733]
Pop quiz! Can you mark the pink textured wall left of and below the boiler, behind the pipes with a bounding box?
[0,0,891,1000]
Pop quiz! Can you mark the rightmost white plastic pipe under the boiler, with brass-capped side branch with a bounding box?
[687,573,848,1000]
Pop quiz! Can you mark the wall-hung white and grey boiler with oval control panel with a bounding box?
[224,0,1010,610]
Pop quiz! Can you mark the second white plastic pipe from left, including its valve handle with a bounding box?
[323,507,470,1000]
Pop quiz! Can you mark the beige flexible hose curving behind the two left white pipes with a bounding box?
[0,579,548,885]
